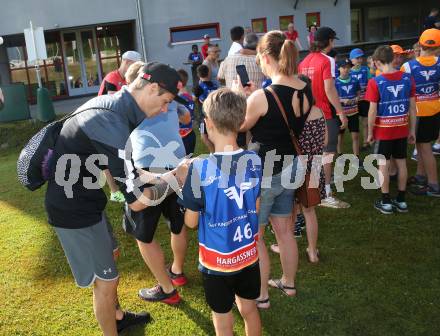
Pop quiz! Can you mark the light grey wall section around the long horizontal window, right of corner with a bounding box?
[142,0,351,69]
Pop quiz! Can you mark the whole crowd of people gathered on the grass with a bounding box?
[37,9,440,335]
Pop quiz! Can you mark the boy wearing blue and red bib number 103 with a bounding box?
[365,46,416,215]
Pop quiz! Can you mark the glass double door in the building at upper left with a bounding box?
[62,29,102,96]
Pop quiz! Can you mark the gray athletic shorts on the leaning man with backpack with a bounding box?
[54,213,119,287]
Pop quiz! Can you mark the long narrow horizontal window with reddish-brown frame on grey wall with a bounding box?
[170,23,220,43]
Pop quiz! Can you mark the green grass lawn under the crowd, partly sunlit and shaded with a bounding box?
[0,122,440,336]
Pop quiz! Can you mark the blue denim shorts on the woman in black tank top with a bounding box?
[258,173,295,225]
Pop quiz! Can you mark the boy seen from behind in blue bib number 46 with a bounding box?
[180,88,262,335]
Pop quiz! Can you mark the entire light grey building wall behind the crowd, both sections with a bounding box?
[0,0,350,85]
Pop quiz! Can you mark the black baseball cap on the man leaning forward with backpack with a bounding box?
[142,62,186,104]
